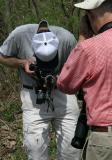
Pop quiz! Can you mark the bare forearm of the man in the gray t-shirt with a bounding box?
[0,55,26,68]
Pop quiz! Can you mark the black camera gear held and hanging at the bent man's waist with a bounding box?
[30,64,56,109]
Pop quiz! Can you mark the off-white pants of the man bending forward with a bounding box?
[21,89,80,160]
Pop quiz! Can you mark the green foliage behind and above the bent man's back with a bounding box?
[0,0,79,36]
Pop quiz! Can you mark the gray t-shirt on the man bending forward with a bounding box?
[0,24,77,86]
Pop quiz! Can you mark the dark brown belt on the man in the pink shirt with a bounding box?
[90,126,112,132]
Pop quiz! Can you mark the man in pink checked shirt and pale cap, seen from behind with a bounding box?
[57,0,112,160]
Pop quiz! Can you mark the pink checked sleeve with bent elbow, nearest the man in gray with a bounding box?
[57,45,90,94]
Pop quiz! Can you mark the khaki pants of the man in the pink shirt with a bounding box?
[86,131,112,160]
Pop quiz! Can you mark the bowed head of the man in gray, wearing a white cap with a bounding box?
[32,21,59,62]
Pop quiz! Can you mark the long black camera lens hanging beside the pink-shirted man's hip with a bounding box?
[71,90,89,149]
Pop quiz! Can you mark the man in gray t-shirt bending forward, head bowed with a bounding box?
[0,21,80,160]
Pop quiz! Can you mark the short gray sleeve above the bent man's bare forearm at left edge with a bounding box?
[0,31,18,57]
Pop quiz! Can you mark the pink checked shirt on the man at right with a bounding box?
[57,29,112,126]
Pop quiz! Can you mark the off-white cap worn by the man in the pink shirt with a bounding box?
[74,0,106,10]
